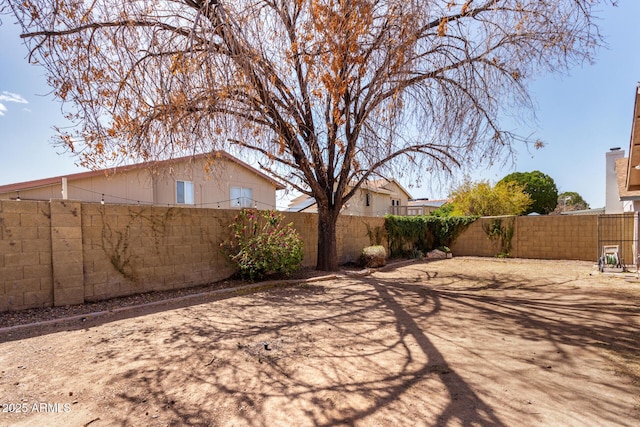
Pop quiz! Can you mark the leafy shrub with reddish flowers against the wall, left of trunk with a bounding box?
[221,209,304,280]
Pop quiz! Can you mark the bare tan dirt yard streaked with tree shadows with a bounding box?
[0,258,640,427]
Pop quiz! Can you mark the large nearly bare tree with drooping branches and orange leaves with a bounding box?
[2,0,609,270]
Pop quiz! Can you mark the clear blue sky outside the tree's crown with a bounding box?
[0,0,640,208]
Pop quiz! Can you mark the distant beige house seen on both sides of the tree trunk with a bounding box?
[287,179,411,216]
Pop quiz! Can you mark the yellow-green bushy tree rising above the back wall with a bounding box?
[451,180,531,216]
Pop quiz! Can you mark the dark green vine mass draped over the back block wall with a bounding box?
[384,215,477,257]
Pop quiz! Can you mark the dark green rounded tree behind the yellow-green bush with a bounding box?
[498,171,558,215]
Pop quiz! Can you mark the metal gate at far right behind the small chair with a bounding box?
[597,212,638,268]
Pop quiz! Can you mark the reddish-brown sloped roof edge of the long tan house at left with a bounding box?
[0,151,285,193]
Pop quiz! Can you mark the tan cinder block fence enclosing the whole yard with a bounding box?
[0,200,633,311]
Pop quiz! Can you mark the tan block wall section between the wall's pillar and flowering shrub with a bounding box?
[82,204,237,301]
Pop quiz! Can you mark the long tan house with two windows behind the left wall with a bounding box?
[0,151,284,209]
